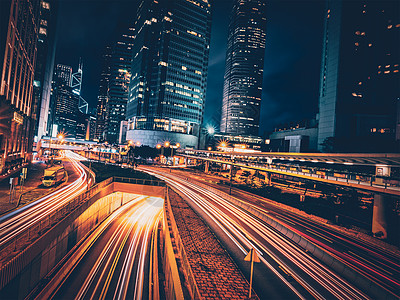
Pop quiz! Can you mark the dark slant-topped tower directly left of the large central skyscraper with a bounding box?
[104,28,133,144]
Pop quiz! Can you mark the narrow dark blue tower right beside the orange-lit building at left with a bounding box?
[33,0,58,139]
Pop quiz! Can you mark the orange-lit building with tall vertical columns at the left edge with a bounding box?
[0,0,40,174]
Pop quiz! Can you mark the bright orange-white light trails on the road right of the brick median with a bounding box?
[141,169,368,299]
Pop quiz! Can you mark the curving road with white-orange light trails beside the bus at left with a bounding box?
[0,151,91,251]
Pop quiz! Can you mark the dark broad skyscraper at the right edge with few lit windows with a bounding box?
[318,0,400,152]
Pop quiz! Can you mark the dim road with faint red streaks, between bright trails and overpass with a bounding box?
[180,172,400,298]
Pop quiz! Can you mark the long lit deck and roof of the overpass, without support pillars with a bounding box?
[176,149,400,196]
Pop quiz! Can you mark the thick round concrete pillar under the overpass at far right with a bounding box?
[372,194,390,239]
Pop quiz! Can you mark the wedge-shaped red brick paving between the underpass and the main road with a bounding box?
[169,190,258,299]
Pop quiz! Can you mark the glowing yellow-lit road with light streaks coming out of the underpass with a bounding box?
[36,196,164,299]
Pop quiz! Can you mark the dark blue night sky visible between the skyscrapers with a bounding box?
[56,0,325,135]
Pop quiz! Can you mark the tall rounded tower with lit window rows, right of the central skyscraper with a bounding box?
[220,0,267,135]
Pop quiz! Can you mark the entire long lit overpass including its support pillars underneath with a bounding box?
[175,149,400,238]
